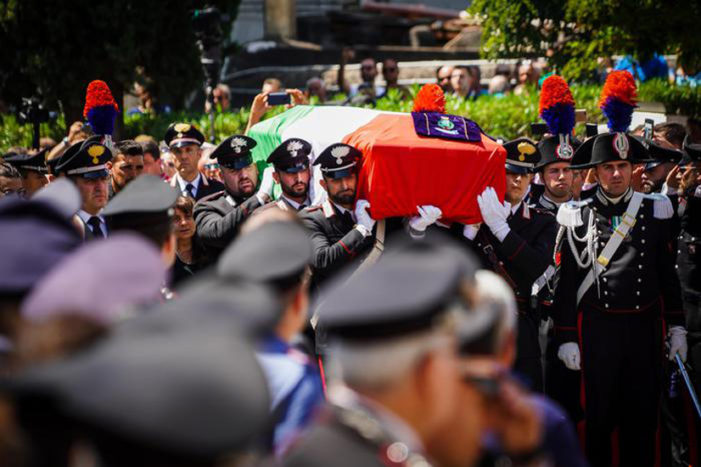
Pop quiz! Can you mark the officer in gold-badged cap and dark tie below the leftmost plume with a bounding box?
[56,136,112,240]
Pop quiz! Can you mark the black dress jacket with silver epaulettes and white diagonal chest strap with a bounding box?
[553,191,683,342]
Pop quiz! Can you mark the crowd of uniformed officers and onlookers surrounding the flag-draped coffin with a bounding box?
[0,65,701,467]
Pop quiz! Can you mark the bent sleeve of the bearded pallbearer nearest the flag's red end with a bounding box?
[302,216,366,270]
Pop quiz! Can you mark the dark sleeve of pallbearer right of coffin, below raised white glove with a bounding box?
[496,215,557,283]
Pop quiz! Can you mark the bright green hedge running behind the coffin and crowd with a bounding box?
[0,81,701,151]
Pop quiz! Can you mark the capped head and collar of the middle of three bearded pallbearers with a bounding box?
[258,138,312,211]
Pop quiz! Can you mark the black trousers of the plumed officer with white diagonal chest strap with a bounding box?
[581,306,662,467]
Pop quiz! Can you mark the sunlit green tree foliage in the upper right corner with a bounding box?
[468,0,701,78]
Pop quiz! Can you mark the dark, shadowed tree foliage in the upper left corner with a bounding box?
[0,0,239,120]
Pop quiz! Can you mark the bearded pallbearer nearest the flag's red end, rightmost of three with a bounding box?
[300,143,375,286]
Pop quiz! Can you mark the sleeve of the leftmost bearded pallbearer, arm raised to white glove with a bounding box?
[194,196,262,248]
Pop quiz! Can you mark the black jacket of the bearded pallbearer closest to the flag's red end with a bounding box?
[300,201,374,286]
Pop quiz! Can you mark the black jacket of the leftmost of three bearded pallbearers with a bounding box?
[193,190,261,264]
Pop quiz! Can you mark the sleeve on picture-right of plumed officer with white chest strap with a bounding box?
[656,219,684,326]
